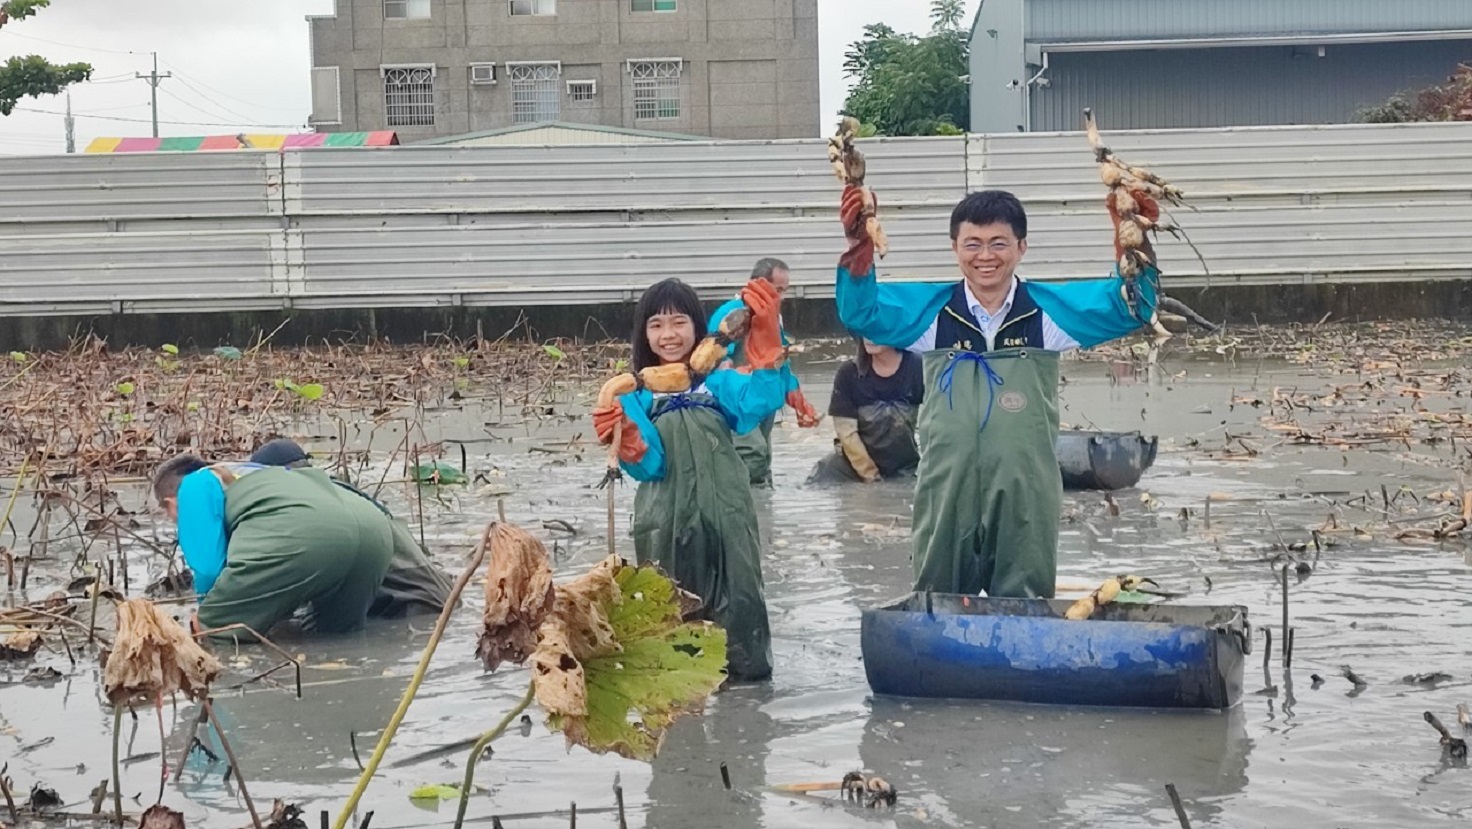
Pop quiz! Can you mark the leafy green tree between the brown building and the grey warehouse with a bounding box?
[843,18,970,135]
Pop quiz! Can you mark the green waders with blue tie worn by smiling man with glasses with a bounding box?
[914,349,1063,598]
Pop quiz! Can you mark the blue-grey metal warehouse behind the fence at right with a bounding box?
[972,0,1472,133]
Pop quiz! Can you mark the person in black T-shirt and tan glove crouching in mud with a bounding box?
[808,339,924,483]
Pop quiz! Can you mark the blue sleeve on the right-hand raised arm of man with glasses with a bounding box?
[1027,268,1160,348]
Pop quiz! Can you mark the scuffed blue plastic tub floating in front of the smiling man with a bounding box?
[861,593,1251,708]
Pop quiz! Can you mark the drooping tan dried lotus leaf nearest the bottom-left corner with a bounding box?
[103,599,219,704]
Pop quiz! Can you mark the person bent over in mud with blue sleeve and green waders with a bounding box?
[153,455,393,639]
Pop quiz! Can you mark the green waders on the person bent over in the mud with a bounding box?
[199,467,394,639]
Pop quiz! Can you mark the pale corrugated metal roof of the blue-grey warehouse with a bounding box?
[1024,0,1472,43]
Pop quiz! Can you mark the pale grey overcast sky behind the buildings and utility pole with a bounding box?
[0,0,979,155]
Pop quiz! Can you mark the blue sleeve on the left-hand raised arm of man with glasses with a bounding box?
[835,265,953,350]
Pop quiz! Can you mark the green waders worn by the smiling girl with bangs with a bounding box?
[633,393,771,680]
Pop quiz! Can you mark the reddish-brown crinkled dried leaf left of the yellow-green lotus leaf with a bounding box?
[477,523,553,670]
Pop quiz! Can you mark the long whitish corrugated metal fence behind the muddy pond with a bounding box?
[0,124,1472,315]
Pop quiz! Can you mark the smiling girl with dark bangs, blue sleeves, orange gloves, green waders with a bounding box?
[593,280,785,680]
